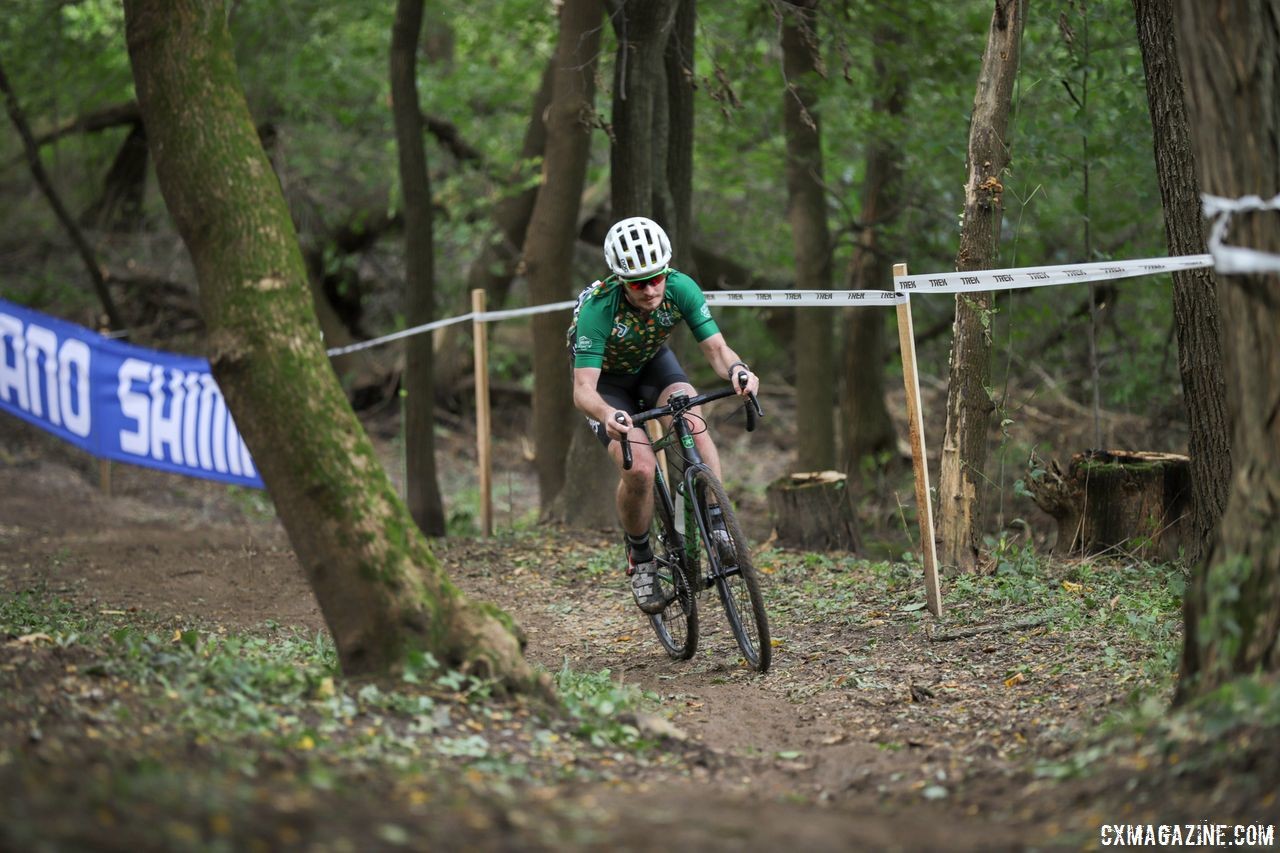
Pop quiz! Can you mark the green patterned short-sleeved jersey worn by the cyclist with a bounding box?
[568,270,719,373]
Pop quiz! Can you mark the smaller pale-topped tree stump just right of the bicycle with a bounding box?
[765,471,860,552]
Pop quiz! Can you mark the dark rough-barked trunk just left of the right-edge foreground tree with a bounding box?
[1133,0,1231,564]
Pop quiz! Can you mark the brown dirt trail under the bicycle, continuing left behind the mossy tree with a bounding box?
[0,414,1264,849]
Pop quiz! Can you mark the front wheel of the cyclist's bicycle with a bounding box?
[694,470,773,672]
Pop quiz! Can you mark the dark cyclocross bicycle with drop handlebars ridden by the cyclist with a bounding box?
[622,379,772,672]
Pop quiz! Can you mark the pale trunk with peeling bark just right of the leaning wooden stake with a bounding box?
[938,0,1023,571]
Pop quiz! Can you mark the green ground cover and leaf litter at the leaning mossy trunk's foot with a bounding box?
[0,590,670,788]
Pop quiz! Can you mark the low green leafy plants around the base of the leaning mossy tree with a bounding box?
[0,589,657,780]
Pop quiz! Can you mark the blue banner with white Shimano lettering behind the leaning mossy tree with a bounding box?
[0,300,262,488]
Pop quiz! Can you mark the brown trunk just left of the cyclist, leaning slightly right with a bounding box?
[524,0,602,512]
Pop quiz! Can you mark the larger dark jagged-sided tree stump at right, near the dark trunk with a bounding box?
[1028,451,1192,560]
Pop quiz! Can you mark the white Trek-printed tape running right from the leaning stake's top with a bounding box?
[893,255,1213,293]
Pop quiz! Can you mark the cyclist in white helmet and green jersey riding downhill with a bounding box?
[568,216,760,613]
